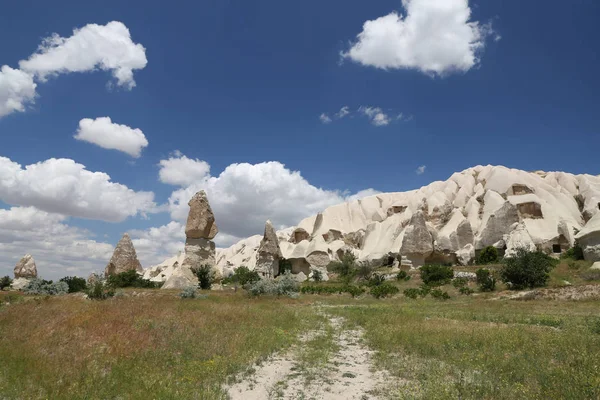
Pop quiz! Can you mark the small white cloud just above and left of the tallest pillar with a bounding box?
[158,151,210,186]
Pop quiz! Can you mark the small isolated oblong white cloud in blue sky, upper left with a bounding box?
[74,117,148,158]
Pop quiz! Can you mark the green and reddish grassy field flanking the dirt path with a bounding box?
[0,260,600,399]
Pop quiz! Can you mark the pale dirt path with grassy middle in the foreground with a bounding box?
[227,316,388,400]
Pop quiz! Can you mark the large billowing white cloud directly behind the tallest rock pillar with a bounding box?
[158,157,376,246]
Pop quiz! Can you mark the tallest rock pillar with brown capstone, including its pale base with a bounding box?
[162,190,221,289]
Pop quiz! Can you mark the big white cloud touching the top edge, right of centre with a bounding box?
[342,0,499,76]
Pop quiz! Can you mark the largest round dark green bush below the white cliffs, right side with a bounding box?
[500,249,556,290]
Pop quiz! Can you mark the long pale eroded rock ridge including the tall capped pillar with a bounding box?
[144,166,600,287]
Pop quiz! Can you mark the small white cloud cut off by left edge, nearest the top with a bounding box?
[0,65,37,118]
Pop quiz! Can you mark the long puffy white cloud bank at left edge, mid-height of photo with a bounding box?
[0,157,156,222]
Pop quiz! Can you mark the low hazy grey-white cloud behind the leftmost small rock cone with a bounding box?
[0,207,113,279]
